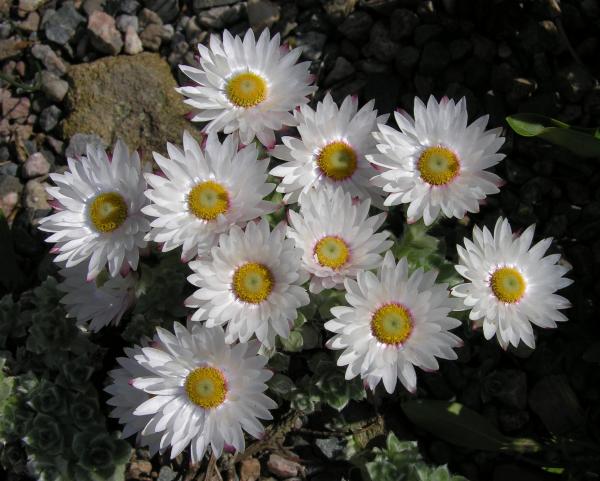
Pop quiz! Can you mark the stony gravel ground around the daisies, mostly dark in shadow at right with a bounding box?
[0,0,600,481]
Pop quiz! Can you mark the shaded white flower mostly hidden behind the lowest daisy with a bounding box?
[104,336,165,456]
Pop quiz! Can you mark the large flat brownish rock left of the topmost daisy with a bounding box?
[62,53,194,161]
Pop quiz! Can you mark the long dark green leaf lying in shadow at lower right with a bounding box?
[402,399,511,451]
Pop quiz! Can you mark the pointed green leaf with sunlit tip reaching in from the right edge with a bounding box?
[506,113,600,157]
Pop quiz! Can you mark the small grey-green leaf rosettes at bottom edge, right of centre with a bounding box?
[365,432,468,481]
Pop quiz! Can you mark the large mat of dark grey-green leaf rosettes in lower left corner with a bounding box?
[0,279,130,481]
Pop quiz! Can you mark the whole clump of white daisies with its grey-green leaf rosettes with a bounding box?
[27,25,570,472]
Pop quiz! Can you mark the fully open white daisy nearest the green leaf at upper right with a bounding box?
[369,96,504,225]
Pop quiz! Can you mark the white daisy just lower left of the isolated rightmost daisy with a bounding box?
[325,251,462,393]
